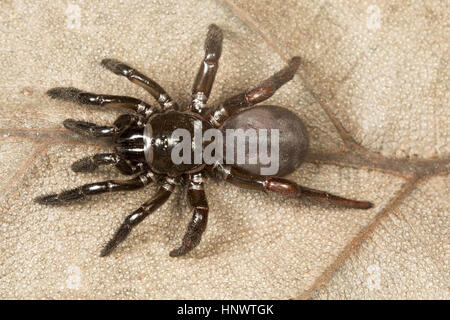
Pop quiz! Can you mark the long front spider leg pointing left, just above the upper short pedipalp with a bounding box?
[47,87,155,118]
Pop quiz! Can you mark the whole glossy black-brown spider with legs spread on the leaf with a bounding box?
[35,24,373,257]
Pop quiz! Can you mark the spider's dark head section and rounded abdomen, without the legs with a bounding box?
[114,106,308,177]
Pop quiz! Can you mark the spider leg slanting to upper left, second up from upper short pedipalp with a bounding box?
[102,59,178,110]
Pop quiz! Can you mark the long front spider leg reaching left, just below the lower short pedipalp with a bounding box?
[35,171,157,205]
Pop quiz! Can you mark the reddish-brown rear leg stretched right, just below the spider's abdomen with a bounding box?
[216,165,373,209]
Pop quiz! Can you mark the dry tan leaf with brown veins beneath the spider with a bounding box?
[0,0,450,299]
